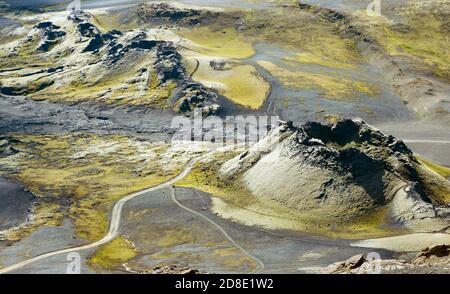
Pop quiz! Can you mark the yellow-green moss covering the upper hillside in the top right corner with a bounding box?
[357,1,450,80]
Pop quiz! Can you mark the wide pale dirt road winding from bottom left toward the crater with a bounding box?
[0,158,199,274]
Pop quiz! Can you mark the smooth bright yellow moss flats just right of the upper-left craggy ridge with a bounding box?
[179,26,270,109]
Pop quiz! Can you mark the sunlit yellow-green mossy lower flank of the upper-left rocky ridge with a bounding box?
[5,42,177,108]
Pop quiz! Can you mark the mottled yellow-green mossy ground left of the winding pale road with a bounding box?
[1,134,187,240]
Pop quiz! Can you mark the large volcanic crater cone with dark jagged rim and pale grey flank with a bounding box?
[221,119,450,230]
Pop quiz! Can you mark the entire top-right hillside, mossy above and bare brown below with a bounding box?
[297,0,450,124]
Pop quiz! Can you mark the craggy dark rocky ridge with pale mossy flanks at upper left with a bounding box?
[0,9,220,115]
